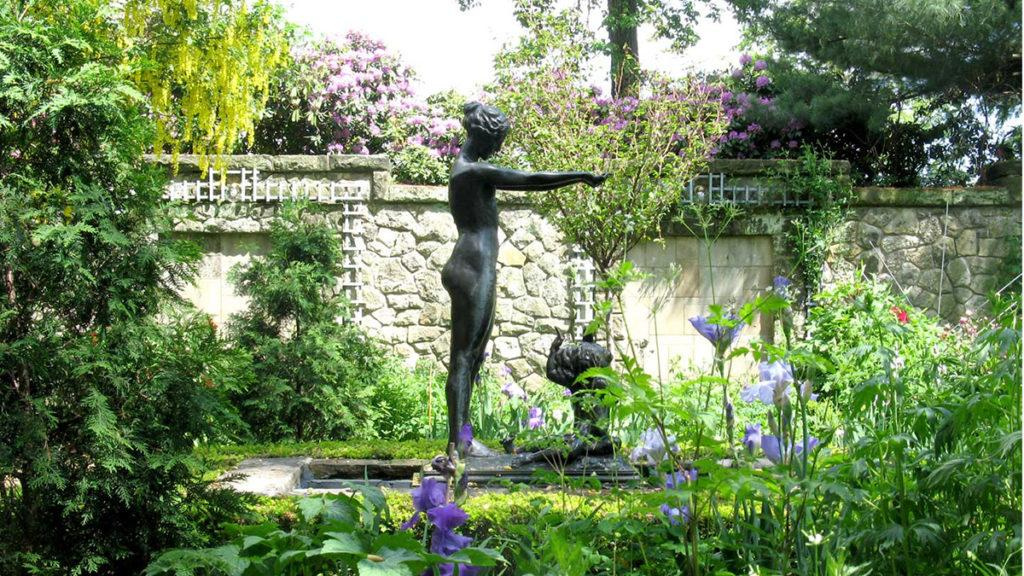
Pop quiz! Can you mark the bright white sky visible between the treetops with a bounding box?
[284,0,739,97]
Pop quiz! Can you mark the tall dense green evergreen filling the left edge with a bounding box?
[0,1,245,575]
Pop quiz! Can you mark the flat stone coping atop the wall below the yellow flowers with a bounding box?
[145,154,391,173]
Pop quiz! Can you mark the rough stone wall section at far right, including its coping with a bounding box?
[836,188,1021,322]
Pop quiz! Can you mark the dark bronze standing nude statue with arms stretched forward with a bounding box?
[441,102,607,456]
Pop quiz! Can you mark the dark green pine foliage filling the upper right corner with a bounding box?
[730,0,1021,181]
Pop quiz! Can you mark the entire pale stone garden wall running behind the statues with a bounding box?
[157,156,1021,383]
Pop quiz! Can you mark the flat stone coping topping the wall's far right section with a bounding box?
[853,187,1021,208]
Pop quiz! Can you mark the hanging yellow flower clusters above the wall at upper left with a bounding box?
[123,0,288,172]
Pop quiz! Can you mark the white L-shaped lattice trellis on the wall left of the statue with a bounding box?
[164,168,370,322]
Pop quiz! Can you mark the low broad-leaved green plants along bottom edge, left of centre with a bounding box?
[145,485,499,576]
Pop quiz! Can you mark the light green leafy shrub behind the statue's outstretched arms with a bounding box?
[495,4,725,278]
